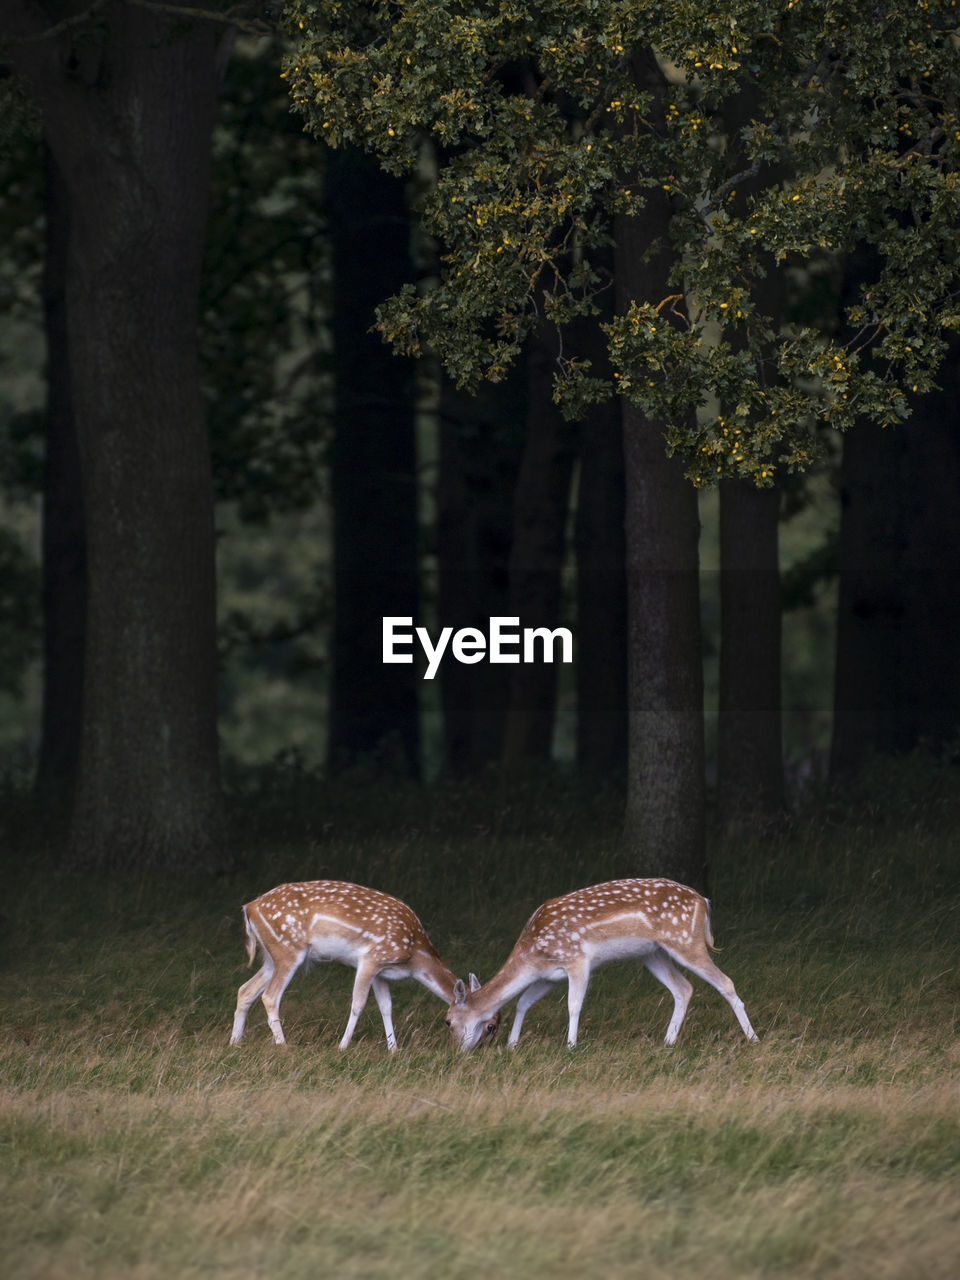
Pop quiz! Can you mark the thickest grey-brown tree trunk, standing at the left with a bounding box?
[14,5,225,870]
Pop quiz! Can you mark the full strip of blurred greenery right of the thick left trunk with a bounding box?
[200,38,332,765]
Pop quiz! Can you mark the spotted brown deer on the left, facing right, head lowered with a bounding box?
[230,881,488,1052]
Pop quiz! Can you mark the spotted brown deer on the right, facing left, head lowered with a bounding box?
[445,879,758,1052]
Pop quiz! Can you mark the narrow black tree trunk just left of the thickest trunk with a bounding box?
[37,148,87,818]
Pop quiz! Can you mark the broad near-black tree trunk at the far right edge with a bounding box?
[831,360,960,776]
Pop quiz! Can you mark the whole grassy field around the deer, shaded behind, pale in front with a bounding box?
[0,768,960,1280]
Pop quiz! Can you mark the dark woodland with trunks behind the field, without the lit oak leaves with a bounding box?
[0,3,960,884]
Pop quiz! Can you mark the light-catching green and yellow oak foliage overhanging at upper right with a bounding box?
[287,0,960,484]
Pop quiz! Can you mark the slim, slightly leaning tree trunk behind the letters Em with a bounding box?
[503,326,575,765]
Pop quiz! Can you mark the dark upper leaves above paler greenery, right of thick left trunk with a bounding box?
[200,40,330,521]
